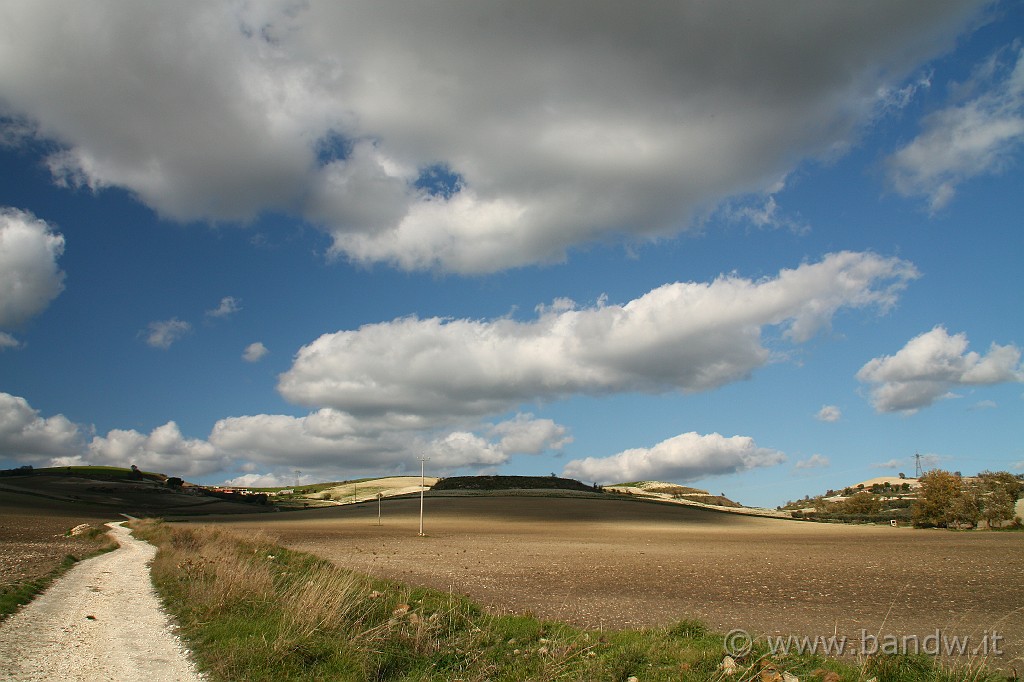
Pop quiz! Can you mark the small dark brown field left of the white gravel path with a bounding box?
[0,491,124,587]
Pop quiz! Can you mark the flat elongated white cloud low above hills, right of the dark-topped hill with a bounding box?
[562,431,785,483]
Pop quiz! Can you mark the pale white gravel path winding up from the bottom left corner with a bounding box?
[0,522,203,682]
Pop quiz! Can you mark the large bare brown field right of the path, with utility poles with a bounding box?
[209,496,1024,670]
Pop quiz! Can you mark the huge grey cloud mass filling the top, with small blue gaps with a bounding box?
[0,0,984,272]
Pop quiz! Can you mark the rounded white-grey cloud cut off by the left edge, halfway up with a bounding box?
[0,207,65,333]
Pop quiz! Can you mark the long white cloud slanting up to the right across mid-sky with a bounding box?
[279,253,916,423]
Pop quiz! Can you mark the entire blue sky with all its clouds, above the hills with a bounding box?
[0,0,1024,506]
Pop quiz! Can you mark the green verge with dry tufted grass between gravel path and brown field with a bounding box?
[132,520,1005,682]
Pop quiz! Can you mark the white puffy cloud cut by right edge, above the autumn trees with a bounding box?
[857,326,1024,414]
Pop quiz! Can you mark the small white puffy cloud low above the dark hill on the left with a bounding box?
[89,422,227,476]
